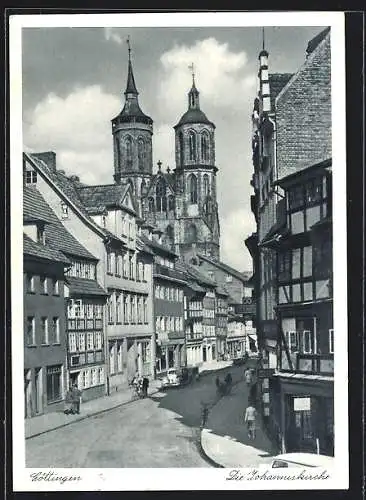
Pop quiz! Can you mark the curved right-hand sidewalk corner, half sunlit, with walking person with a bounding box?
[201,381,277,468]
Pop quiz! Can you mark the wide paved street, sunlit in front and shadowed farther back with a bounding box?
[26,367,243,468]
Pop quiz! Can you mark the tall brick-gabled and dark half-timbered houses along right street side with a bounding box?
[246,29,335,455]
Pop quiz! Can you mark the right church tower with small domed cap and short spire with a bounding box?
[174,65,220,260]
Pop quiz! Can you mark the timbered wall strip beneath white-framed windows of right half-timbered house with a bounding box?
[281,352,334,376]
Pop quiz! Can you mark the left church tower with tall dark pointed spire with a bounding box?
[112,40,153,215]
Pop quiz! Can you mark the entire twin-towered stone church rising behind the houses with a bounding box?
[112,48,220,261]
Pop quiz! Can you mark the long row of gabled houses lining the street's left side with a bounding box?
[23,152,256,417]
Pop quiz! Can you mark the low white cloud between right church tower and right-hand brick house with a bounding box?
[220,208,255,271]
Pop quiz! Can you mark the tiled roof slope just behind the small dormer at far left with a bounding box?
[23,186,98,261]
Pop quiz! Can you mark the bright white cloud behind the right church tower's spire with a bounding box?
[158,38,255,123]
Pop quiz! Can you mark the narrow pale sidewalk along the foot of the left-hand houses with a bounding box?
[24,380,161,439]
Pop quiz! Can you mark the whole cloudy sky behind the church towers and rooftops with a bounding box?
[22,26,322,271]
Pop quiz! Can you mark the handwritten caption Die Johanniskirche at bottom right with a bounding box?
[226,469,330,481]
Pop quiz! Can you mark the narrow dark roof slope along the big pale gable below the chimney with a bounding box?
[23,152,124,245]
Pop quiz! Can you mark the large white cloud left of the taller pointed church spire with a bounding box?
[24,85,121,183]
